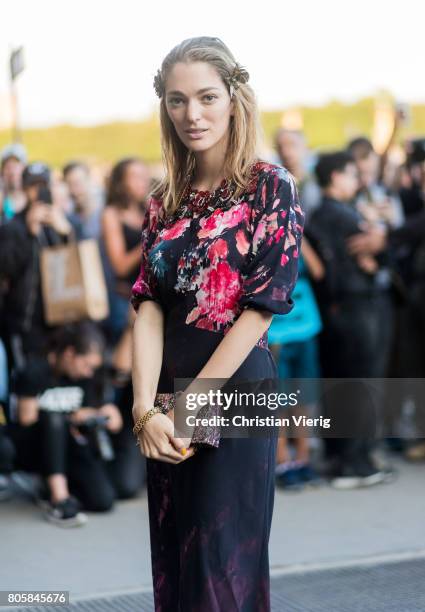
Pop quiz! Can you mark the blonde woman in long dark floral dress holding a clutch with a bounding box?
[132,37,303,612]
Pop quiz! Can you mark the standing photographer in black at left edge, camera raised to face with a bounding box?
[0,163,72,369]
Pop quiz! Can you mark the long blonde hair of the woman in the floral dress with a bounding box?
[152,36,260,214]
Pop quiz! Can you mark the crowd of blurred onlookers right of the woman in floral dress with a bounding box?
[270,129,425,490]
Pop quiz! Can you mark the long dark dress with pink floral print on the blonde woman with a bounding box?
[132,162,304,612]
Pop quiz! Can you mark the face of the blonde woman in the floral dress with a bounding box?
[165,62,233,153]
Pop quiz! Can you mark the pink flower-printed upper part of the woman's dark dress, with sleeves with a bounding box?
[132,162,303,333]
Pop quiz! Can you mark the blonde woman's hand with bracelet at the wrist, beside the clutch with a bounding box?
[138,413,195,464]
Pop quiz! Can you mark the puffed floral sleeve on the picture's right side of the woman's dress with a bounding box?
[240,166,304,314]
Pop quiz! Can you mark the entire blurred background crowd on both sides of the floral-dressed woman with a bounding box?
[0,129,425,526]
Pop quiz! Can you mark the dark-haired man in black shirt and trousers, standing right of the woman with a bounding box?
[307,152,392,489]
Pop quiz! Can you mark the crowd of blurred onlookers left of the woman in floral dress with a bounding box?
[0,145,151,526]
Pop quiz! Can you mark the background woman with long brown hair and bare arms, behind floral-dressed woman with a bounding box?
[102,157,150,496]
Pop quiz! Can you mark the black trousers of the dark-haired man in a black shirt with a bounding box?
[320,292,394,464]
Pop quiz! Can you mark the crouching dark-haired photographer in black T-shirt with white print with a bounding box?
[10,322,125,527]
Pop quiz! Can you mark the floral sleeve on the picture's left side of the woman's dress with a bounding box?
[131,198,159,312]
